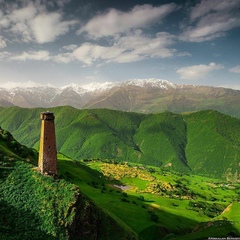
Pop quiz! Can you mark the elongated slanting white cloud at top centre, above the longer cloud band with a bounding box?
[77,4,176,38]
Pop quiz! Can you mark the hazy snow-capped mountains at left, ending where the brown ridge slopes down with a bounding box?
[0,83,117,108]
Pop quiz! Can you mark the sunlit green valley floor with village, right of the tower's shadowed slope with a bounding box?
[59,157,240,240]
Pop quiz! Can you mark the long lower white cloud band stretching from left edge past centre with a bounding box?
[1,31,178,65]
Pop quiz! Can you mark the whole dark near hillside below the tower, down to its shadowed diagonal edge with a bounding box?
[0,129,137,240]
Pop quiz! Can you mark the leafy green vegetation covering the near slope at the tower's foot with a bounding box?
[0,129,77,240]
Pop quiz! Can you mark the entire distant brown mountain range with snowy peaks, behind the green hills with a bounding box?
[0,79,240,117]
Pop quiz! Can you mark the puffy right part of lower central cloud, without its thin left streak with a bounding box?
[72,31,176,65]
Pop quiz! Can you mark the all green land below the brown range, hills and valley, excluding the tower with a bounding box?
[0,106,240,240]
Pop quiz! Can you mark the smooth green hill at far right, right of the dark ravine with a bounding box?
[184,111,240,180]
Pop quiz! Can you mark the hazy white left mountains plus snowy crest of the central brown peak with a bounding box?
[0,78,177,107]
